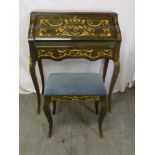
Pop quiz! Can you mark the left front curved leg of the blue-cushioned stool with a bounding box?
[43,96,53,137]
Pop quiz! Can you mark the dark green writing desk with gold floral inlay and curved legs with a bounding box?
[28,12,121,137]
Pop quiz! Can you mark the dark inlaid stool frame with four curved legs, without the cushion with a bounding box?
[43,96,108,137]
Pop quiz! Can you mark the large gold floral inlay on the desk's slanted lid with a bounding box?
[37,16,112,38]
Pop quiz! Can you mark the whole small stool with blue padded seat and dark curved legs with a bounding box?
[43,73,107,137]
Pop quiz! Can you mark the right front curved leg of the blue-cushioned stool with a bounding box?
[98,97,107,137]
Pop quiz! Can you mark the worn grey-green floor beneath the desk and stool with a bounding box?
[19,89,135,155]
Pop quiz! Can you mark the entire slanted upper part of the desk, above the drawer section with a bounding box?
[28,12,121,41]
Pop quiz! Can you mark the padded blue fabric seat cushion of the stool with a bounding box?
[44,73,107,96]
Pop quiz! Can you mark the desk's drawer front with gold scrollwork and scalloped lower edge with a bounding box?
[36,47,114,61]
